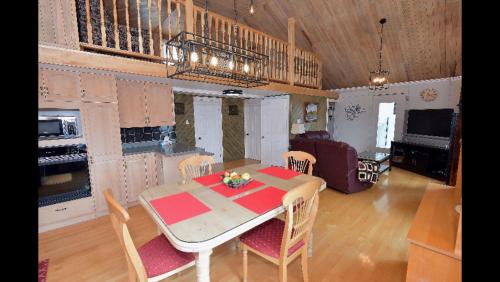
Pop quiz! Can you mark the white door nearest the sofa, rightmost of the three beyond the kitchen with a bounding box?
[261,95,290,166]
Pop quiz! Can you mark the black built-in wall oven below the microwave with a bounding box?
[38,144,91,207]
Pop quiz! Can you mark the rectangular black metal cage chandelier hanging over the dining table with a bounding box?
[166,0,269,88]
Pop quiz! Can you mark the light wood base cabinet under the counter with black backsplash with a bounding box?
[125,153,162,206]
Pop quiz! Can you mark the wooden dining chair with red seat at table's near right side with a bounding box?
[240,180,321,282]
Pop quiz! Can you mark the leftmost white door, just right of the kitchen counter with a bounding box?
[193,96,223,162]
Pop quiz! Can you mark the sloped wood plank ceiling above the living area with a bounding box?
[193,0,462,89]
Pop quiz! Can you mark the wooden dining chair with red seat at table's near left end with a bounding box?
[104,189,195,282]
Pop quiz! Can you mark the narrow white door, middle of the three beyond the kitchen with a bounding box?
[244,99,261,160]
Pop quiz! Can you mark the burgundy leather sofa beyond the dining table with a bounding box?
[290,131,372,194]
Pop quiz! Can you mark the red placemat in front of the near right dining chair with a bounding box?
[234,186,286,214]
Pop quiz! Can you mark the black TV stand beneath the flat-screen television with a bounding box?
[390,141,450,182]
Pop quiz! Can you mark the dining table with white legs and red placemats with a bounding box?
[139,164,326,282]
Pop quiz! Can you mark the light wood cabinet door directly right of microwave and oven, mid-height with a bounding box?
[82,103,122,159]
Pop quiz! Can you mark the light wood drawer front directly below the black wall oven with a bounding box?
[38,197,94,226]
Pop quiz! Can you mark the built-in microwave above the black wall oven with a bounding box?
[38,110,82,140]
